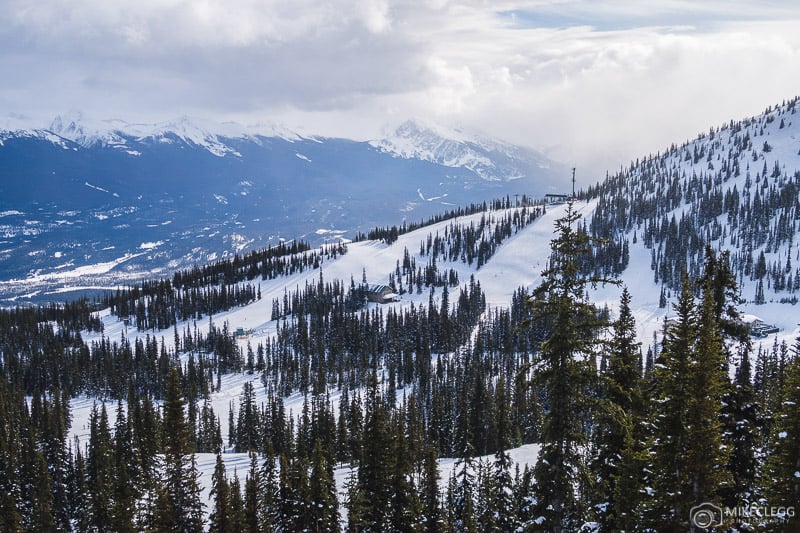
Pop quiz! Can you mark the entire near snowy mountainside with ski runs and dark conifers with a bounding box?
[0,103,800,532]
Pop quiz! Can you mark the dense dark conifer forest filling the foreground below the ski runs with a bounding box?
[0,204,800,531]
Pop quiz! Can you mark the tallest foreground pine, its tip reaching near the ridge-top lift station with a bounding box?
[531,206,616,533]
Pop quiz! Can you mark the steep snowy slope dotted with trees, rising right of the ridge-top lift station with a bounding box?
[586,95,800,303]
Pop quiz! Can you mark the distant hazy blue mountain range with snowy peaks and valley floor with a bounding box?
[0,114,567,297]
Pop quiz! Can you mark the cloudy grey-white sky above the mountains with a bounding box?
[0,0,800,174]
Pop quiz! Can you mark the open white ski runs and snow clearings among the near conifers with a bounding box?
[72,194,800,520]
